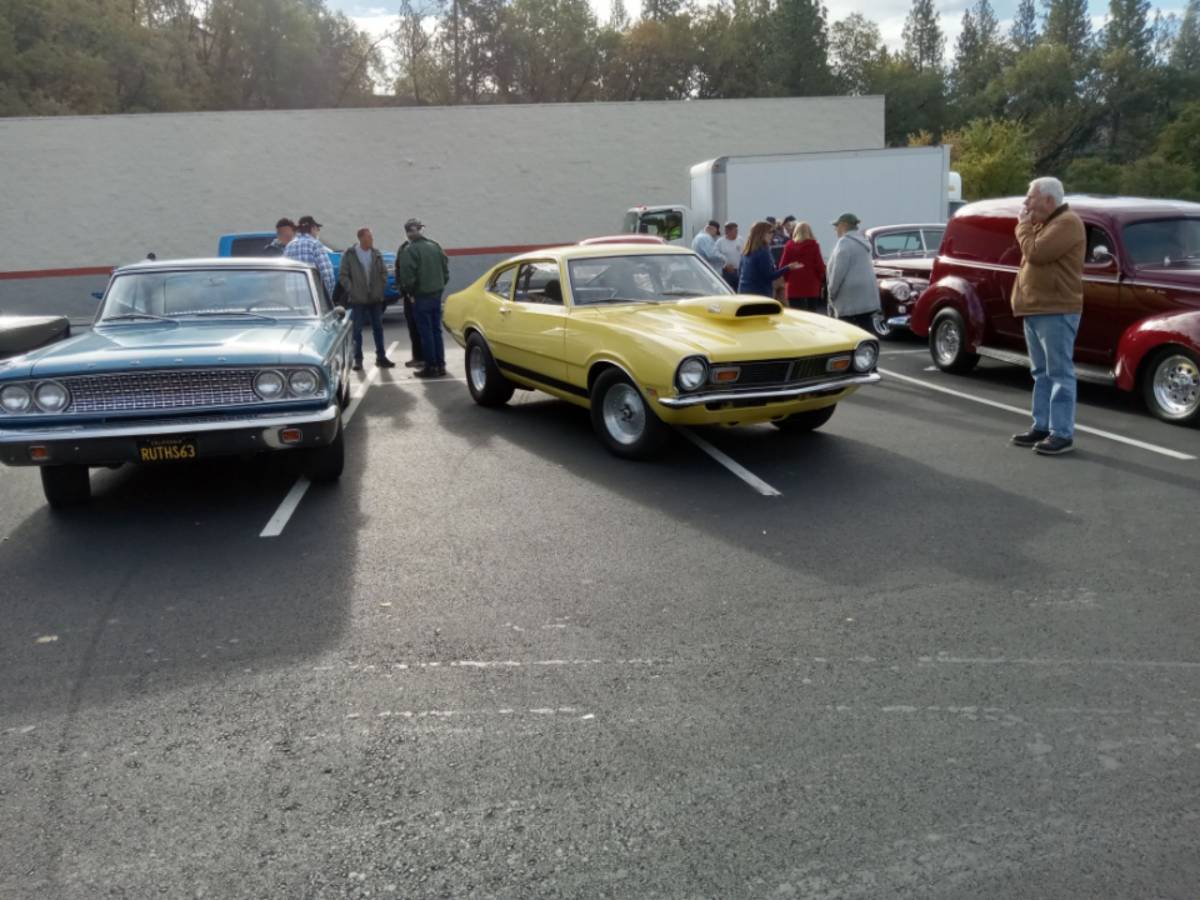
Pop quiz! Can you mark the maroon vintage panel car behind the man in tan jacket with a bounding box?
[908,196,1200,424]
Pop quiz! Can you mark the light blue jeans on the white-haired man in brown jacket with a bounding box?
[1025,312,1079,440]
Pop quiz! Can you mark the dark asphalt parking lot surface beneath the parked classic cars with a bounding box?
[0,328,1200,900]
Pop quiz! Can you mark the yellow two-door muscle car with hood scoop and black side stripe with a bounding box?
[445,244,880,457]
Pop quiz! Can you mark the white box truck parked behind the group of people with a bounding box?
[622,146,961,247]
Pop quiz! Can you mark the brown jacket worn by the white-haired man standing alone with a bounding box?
[1013,203,1087,316]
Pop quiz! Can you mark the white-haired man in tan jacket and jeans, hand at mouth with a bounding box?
[1013,178,1087,456]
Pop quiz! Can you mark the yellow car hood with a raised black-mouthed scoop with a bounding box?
[584,295,870,362]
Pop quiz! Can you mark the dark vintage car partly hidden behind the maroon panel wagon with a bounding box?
[863,223,946,337]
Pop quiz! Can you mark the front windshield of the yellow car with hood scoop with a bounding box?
[566,253,733,306]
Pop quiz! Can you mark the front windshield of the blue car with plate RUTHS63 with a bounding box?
[100,270,316,322]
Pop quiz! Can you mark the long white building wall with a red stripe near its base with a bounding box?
[0,97,883,273]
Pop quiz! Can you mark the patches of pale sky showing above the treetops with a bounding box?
[326,0,1186,63]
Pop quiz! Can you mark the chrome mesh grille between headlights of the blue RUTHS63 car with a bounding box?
[61,368,262,413]
